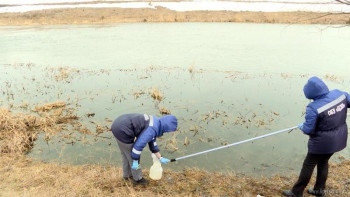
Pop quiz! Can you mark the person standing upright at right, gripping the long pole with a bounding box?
[283,76,350,196]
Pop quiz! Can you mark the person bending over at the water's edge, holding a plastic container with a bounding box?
[112,113,177,185]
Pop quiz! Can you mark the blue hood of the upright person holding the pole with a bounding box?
[304,76,329,100]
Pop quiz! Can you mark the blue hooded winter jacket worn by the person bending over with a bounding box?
[112,114,177,160]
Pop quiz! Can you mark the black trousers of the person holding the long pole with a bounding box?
[292,153,333,196]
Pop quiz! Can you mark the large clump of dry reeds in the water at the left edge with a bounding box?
[0,101,78,154]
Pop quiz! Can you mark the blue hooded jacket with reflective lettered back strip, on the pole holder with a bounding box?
[301,77,350,154]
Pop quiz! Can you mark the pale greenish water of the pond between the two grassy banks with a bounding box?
[0,23,350,175]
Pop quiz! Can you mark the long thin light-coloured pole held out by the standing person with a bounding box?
[170,113,350,162]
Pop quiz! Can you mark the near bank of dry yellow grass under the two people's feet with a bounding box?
[0,154,350,197]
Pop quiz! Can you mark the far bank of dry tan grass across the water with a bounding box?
[0,7,350,26]
